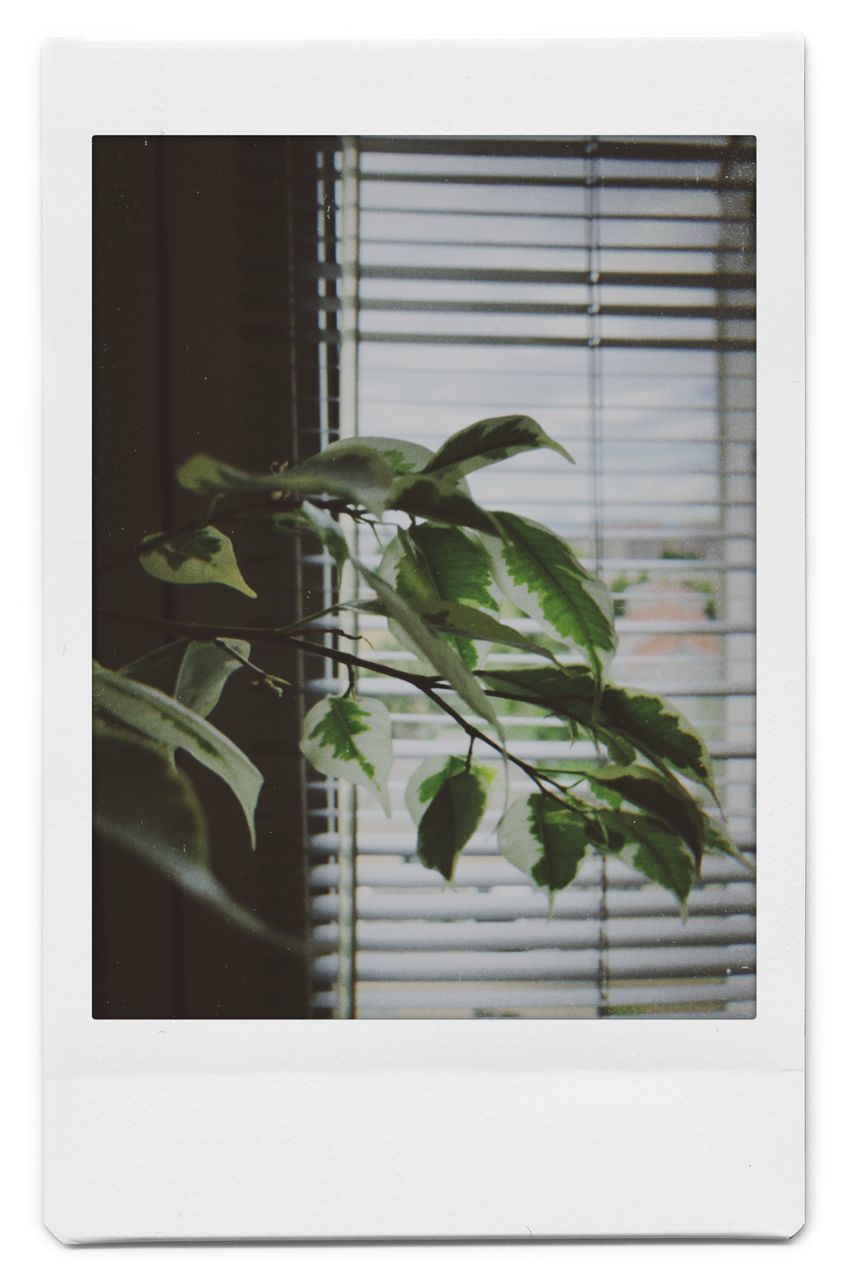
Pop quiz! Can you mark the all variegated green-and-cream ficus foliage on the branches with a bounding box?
[93,416,739,946]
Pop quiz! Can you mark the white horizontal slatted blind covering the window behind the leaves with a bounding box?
[305,137,756,1018]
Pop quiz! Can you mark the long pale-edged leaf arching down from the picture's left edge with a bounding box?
[92,664,264,847]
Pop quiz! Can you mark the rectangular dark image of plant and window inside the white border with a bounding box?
[92,134,757,1019]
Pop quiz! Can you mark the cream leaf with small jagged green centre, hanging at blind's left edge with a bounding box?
[300,695,392,817]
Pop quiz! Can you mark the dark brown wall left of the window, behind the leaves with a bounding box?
[92,137,333,1018]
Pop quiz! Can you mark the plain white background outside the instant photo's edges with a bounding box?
[0,0,853,1276]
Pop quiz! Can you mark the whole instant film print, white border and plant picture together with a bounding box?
[44,37,804,1243]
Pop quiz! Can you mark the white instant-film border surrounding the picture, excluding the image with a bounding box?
[44,36,806,1243]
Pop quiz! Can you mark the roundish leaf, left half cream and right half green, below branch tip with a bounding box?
[498,792,589,893]
